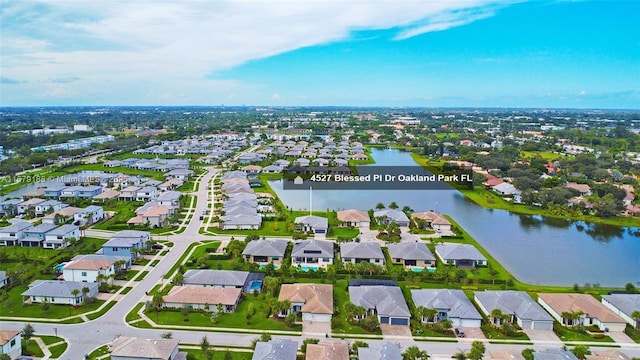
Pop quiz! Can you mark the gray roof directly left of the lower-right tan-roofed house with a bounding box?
[473,290,553,321]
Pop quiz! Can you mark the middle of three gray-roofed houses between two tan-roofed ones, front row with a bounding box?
[411,289,482,328]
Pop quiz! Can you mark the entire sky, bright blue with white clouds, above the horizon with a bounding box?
[0,0,640,109]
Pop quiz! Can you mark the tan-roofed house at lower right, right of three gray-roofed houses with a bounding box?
[538,294,627,331]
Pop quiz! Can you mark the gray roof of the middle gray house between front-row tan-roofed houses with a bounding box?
[411,289,482,320]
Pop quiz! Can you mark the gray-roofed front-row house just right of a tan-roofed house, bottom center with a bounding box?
[349,285,411,326]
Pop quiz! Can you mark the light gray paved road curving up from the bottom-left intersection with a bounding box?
[0,162,640,360]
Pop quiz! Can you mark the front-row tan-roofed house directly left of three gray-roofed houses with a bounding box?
[278,284,333,323]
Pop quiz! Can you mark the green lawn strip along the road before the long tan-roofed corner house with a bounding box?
[147,294,301,331]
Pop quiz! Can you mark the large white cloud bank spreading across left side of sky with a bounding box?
[0,0,520,104]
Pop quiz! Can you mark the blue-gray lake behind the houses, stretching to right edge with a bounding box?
[270,149,640,286]
